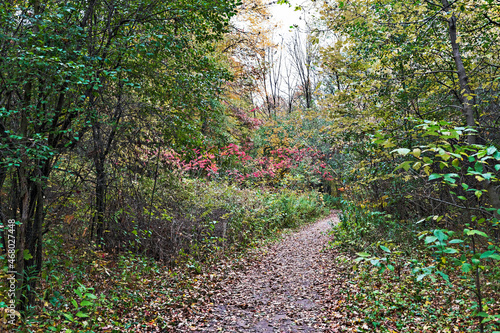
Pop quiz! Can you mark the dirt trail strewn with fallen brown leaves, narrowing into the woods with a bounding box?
[186,213,338,333]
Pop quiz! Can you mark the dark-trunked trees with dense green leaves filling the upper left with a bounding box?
[0,0,242,310]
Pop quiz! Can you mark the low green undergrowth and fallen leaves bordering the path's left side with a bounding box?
[5,179,327,332]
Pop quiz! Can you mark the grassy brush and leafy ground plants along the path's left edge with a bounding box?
[12,174,328,332]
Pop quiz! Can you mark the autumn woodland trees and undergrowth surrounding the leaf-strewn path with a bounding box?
[0,0,500,332]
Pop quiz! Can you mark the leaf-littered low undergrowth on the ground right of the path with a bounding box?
[330,200,500,332]
